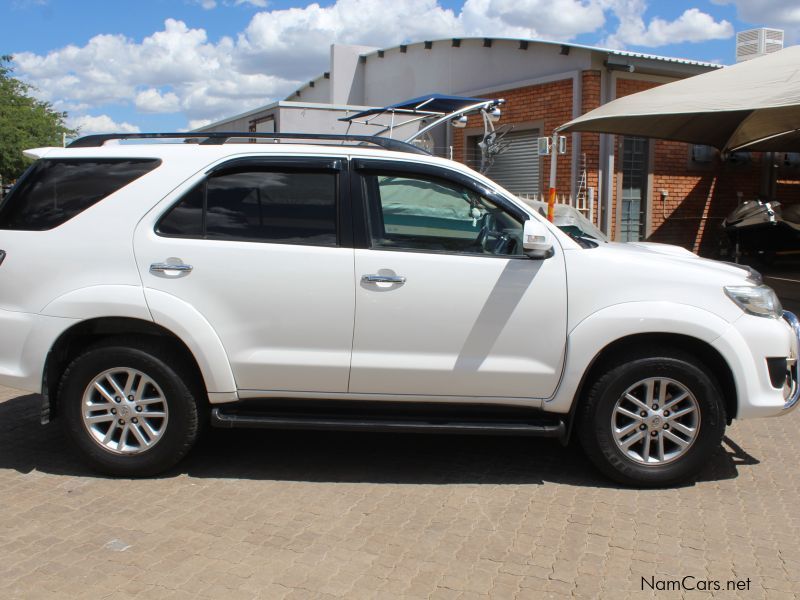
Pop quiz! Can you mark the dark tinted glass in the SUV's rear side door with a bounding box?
[158,169,337,246]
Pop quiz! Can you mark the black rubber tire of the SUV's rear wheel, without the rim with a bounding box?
[58,339,199,477]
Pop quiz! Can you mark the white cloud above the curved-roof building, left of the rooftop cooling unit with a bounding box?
[604,0,733,48]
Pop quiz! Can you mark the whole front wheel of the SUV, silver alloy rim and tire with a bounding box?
[579,350,725,486]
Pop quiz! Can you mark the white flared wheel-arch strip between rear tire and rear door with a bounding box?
[144,288,237,403]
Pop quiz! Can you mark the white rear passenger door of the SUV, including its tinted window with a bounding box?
[135,159,354,392]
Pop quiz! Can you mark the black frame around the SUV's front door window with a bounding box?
[350,159,531,260]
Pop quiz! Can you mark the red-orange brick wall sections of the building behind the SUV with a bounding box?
[453,71,800,256]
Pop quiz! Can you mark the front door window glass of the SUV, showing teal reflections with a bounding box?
[364,174,522,256]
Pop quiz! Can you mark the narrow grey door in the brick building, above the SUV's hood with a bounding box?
[620,136,649,242]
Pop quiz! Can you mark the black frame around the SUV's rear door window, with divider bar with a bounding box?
[153,156,353,248]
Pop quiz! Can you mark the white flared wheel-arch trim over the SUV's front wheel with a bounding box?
[544,302,731,413]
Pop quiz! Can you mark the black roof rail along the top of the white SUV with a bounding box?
[67,131,429,154]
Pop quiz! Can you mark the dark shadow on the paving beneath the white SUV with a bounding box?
[0,395,759,487]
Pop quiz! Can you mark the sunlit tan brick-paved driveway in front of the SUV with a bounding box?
[0,382,800,600]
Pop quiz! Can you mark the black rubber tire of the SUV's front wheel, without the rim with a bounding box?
[578,349,726,487]
